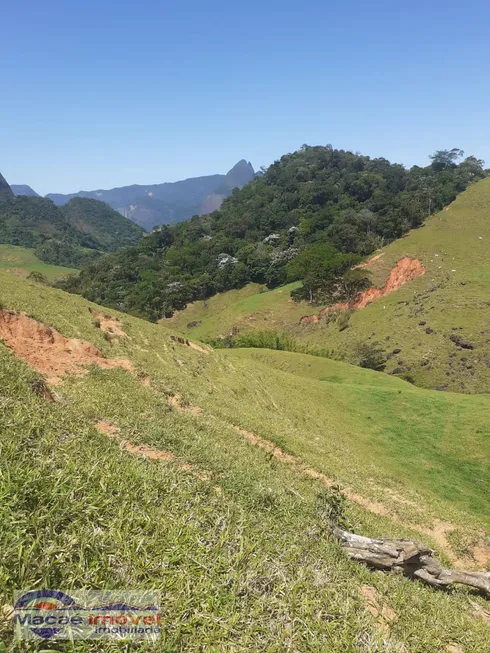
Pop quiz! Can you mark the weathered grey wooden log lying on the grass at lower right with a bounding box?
[332,528,490,599]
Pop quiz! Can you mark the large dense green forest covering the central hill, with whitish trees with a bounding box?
[58,145,487,320]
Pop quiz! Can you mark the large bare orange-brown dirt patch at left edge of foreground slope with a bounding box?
[0,310,132,384]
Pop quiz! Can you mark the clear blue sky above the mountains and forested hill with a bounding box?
[0,0,490,194]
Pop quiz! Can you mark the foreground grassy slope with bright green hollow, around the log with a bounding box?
[0,271,490,653]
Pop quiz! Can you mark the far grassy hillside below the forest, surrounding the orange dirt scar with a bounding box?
[164,174,490,393]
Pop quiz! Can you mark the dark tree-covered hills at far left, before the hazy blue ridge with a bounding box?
[0,195,143,267]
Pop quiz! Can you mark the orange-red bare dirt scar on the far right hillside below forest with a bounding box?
[300,256,425,324]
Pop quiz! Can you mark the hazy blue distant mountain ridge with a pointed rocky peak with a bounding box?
[46,160,255,230]
